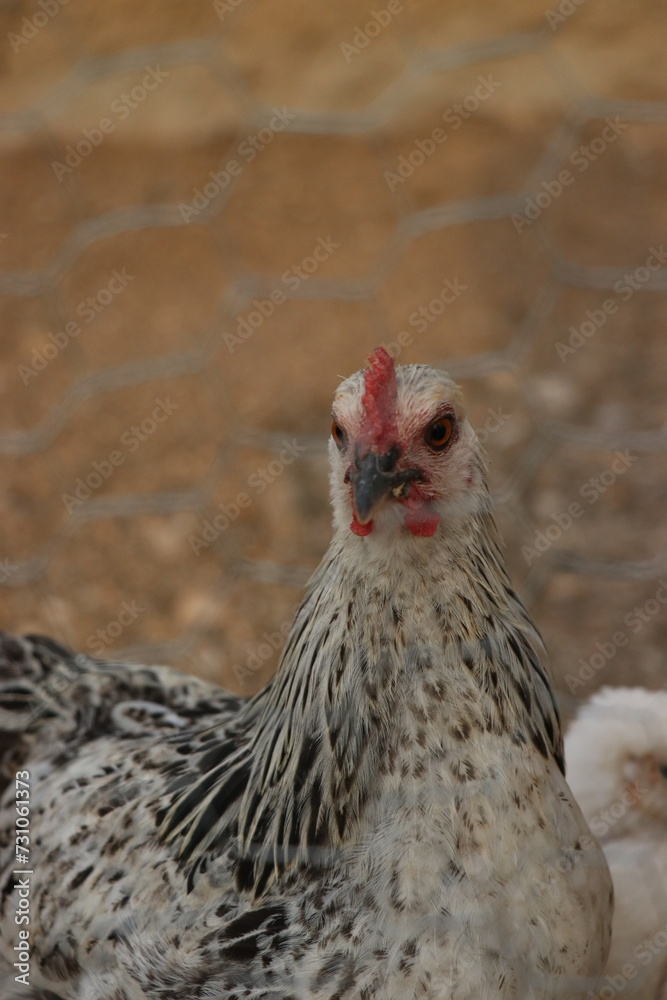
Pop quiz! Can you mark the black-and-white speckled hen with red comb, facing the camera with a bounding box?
[0,348,611,1000]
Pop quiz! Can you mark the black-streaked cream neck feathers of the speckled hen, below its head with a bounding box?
[165,511,562,891]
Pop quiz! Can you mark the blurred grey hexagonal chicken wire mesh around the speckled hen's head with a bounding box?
[0,0,667,712]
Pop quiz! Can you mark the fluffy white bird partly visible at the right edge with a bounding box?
[565,687,667,1000]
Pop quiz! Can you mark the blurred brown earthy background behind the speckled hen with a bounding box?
[0,0,667,712]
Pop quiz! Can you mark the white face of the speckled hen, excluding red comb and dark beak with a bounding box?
[329,365,488,543]
